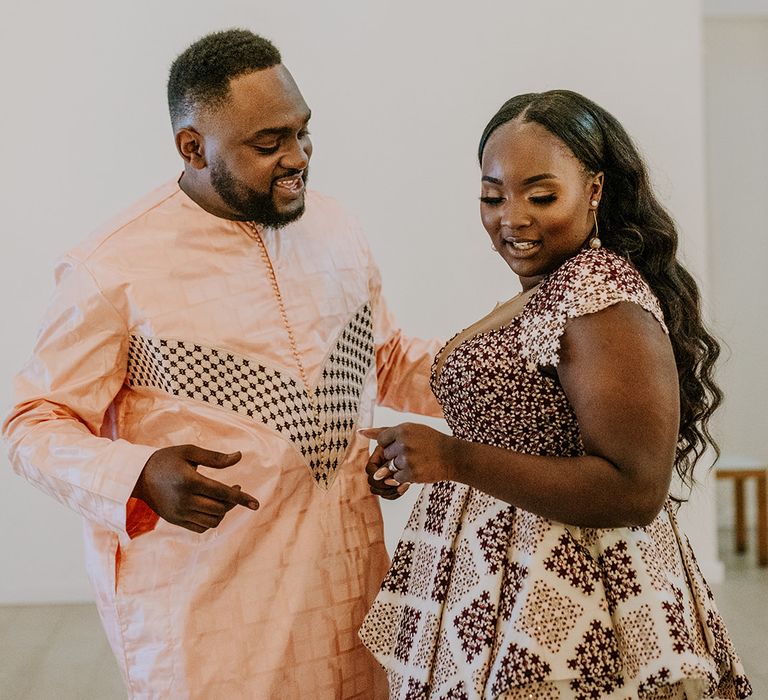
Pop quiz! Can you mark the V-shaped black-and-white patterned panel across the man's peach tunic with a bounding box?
[126,304,375,488]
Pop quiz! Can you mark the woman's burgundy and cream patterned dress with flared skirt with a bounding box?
[360,250,751,700]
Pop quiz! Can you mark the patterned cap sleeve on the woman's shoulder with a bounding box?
[519,249,669,366]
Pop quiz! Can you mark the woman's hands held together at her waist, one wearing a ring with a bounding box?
[358,423,459,500]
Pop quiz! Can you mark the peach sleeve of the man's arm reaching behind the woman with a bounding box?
[366,246,443,418]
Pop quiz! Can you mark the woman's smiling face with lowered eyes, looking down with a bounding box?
[480,121,603,289]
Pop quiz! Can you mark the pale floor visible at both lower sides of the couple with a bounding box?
[0,532,768,700]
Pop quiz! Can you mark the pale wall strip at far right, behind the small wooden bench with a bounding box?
[704,17,768,526]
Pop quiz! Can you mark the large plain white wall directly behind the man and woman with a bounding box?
[0,0,718,602]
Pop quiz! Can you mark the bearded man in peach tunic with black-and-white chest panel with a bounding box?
[4,30,439,699]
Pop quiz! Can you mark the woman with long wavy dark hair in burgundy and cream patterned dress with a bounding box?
[360,90,751,700]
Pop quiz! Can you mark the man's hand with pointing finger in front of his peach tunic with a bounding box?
[131,445,259,532]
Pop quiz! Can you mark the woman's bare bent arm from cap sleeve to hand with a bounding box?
[360,302,679,527]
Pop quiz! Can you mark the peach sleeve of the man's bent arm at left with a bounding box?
[3,259,156,535]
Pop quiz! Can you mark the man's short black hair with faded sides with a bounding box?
[168,29,281,127]
